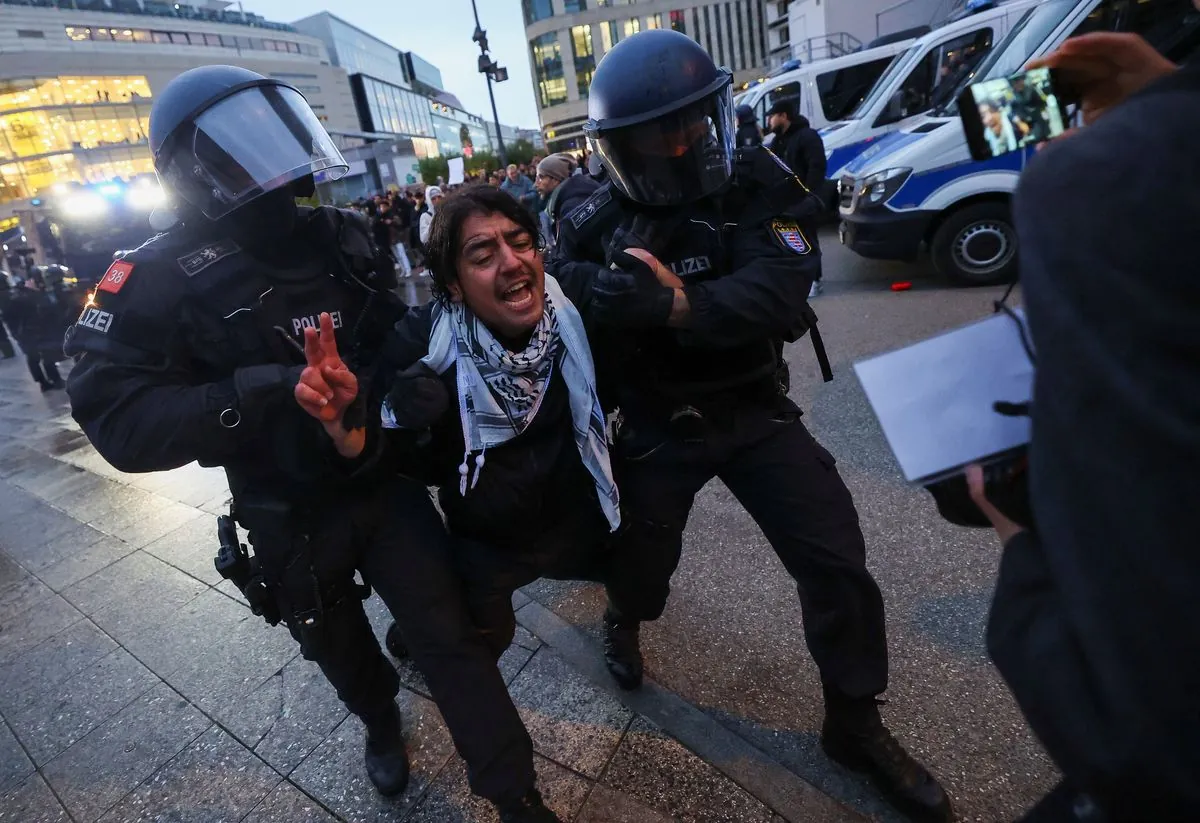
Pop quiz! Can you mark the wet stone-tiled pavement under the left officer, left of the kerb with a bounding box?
[0,360,864,823]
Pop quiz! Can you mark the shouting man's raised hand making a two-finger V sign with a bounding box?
[295,312,366,457]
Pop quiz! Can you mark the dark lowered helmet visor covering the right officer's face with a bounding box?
[592,85,736,205]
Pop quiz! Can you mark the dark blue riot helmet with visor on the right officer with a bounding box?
[583,29,736,205]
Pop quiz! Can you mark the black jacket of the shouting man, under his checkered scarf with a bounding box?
[384,268,608,549]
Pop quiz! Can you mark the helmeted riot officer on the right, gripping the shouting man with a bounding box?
[552,30,953,821]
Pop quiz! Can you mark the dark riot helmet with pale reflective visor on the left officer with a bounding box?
[150,66,349,220]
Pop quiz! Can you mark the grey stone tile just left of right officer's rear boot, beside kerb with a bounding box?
[509,649,634,779]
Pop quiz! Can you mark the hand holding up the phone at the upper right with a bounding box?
[1026,32,1176,124]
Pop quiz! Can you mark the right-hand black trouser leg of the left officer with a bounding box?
[360,480,535,803]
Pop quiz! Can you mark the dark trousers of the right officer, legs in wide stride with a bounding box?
[608,397,888,701]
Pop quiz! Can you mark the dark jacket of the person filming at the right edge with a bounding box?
[988,62,1200,823]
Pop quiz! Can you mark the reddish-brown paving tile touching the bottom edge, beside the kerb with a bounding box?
[600,717,775,823]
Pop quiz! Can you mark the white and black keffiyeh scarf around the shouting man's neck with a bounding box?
[383,275,620,530]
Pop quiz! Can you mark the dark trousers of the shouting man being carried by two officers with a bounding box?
[453,513,611,659]
